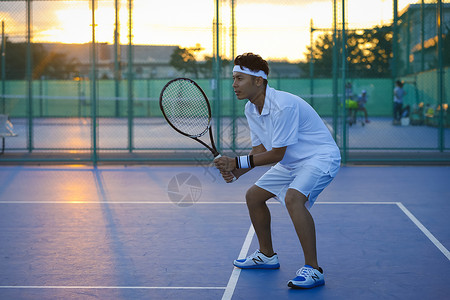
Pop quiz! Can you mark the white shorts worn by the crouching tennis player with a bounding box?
[255,163,339,209]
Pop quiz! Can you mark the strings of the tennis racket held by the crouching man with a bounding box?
[161,80,210,137]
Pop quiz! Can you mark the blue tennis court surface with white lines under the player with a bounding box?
[0,166,450,300]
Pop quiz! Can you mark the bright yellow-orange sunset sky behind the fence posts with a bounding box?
[0,0,416,61]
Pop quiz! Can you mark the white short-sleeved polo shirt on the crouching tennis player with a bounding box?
[245,86,341,177]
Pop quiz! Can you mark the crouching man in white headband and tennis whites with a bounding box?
[214,53,341,288]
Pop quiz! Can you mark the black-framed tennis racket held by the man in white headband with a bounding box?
[159,78,236,181]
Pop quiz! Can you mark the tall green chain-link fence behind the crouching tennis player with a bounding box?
[0,0,450,164]
